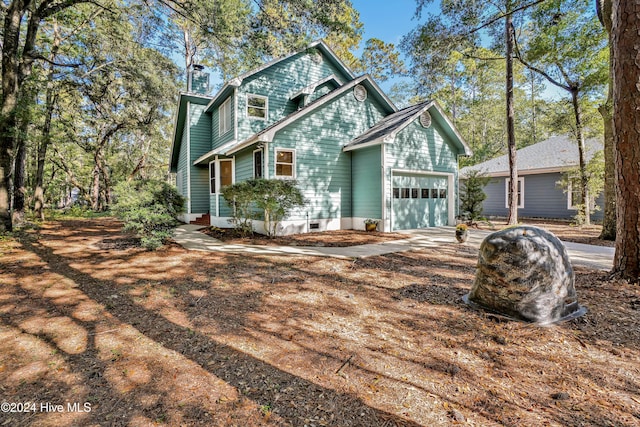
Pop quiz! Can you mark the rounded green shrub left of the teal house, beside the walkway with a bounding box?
[112,179,185,250]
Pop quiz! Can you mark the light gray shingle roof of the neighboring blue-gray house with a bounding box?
[460,135,603,176]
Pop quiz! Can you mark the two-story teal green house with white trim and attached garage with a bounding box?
[169,41,471,234]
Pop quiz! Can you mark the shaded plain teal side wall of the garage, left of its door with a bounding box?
[351,145,382,219]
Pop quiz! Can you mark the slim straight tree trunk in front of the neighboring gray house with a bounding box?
[505,7,518,225]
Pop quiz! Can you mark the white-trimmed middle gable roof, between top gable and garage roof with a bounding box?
[193,74,396,165]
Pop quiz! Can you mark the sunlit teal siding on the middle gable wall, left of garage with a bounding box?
[269,91,383,219]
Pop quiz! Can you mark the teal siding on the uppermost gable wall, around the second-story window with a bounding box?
[237,52,350,141]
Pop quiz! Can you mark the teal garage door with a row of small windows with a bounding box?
[391,174,449,230]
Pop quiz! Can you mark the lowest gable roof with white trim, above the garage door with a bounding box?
[343,101,471,156]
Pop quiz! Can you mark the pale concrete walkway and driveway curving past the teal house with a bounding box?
[173,224,614,271]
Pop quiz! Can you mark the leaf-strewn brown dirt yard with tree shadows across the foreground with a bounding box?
[0,218,640,427]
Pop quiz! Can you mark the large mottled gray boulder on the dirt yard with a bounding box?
[465,226,586,324]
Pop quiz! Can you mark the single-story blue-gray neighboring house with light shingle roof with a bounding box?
[460,135,603,221]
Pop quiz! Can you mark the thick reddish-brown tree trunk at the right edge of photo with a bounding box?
[611,0,640,282]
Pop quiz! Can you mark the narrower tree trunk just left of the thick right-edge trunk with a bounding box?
[596,0,616,240]
